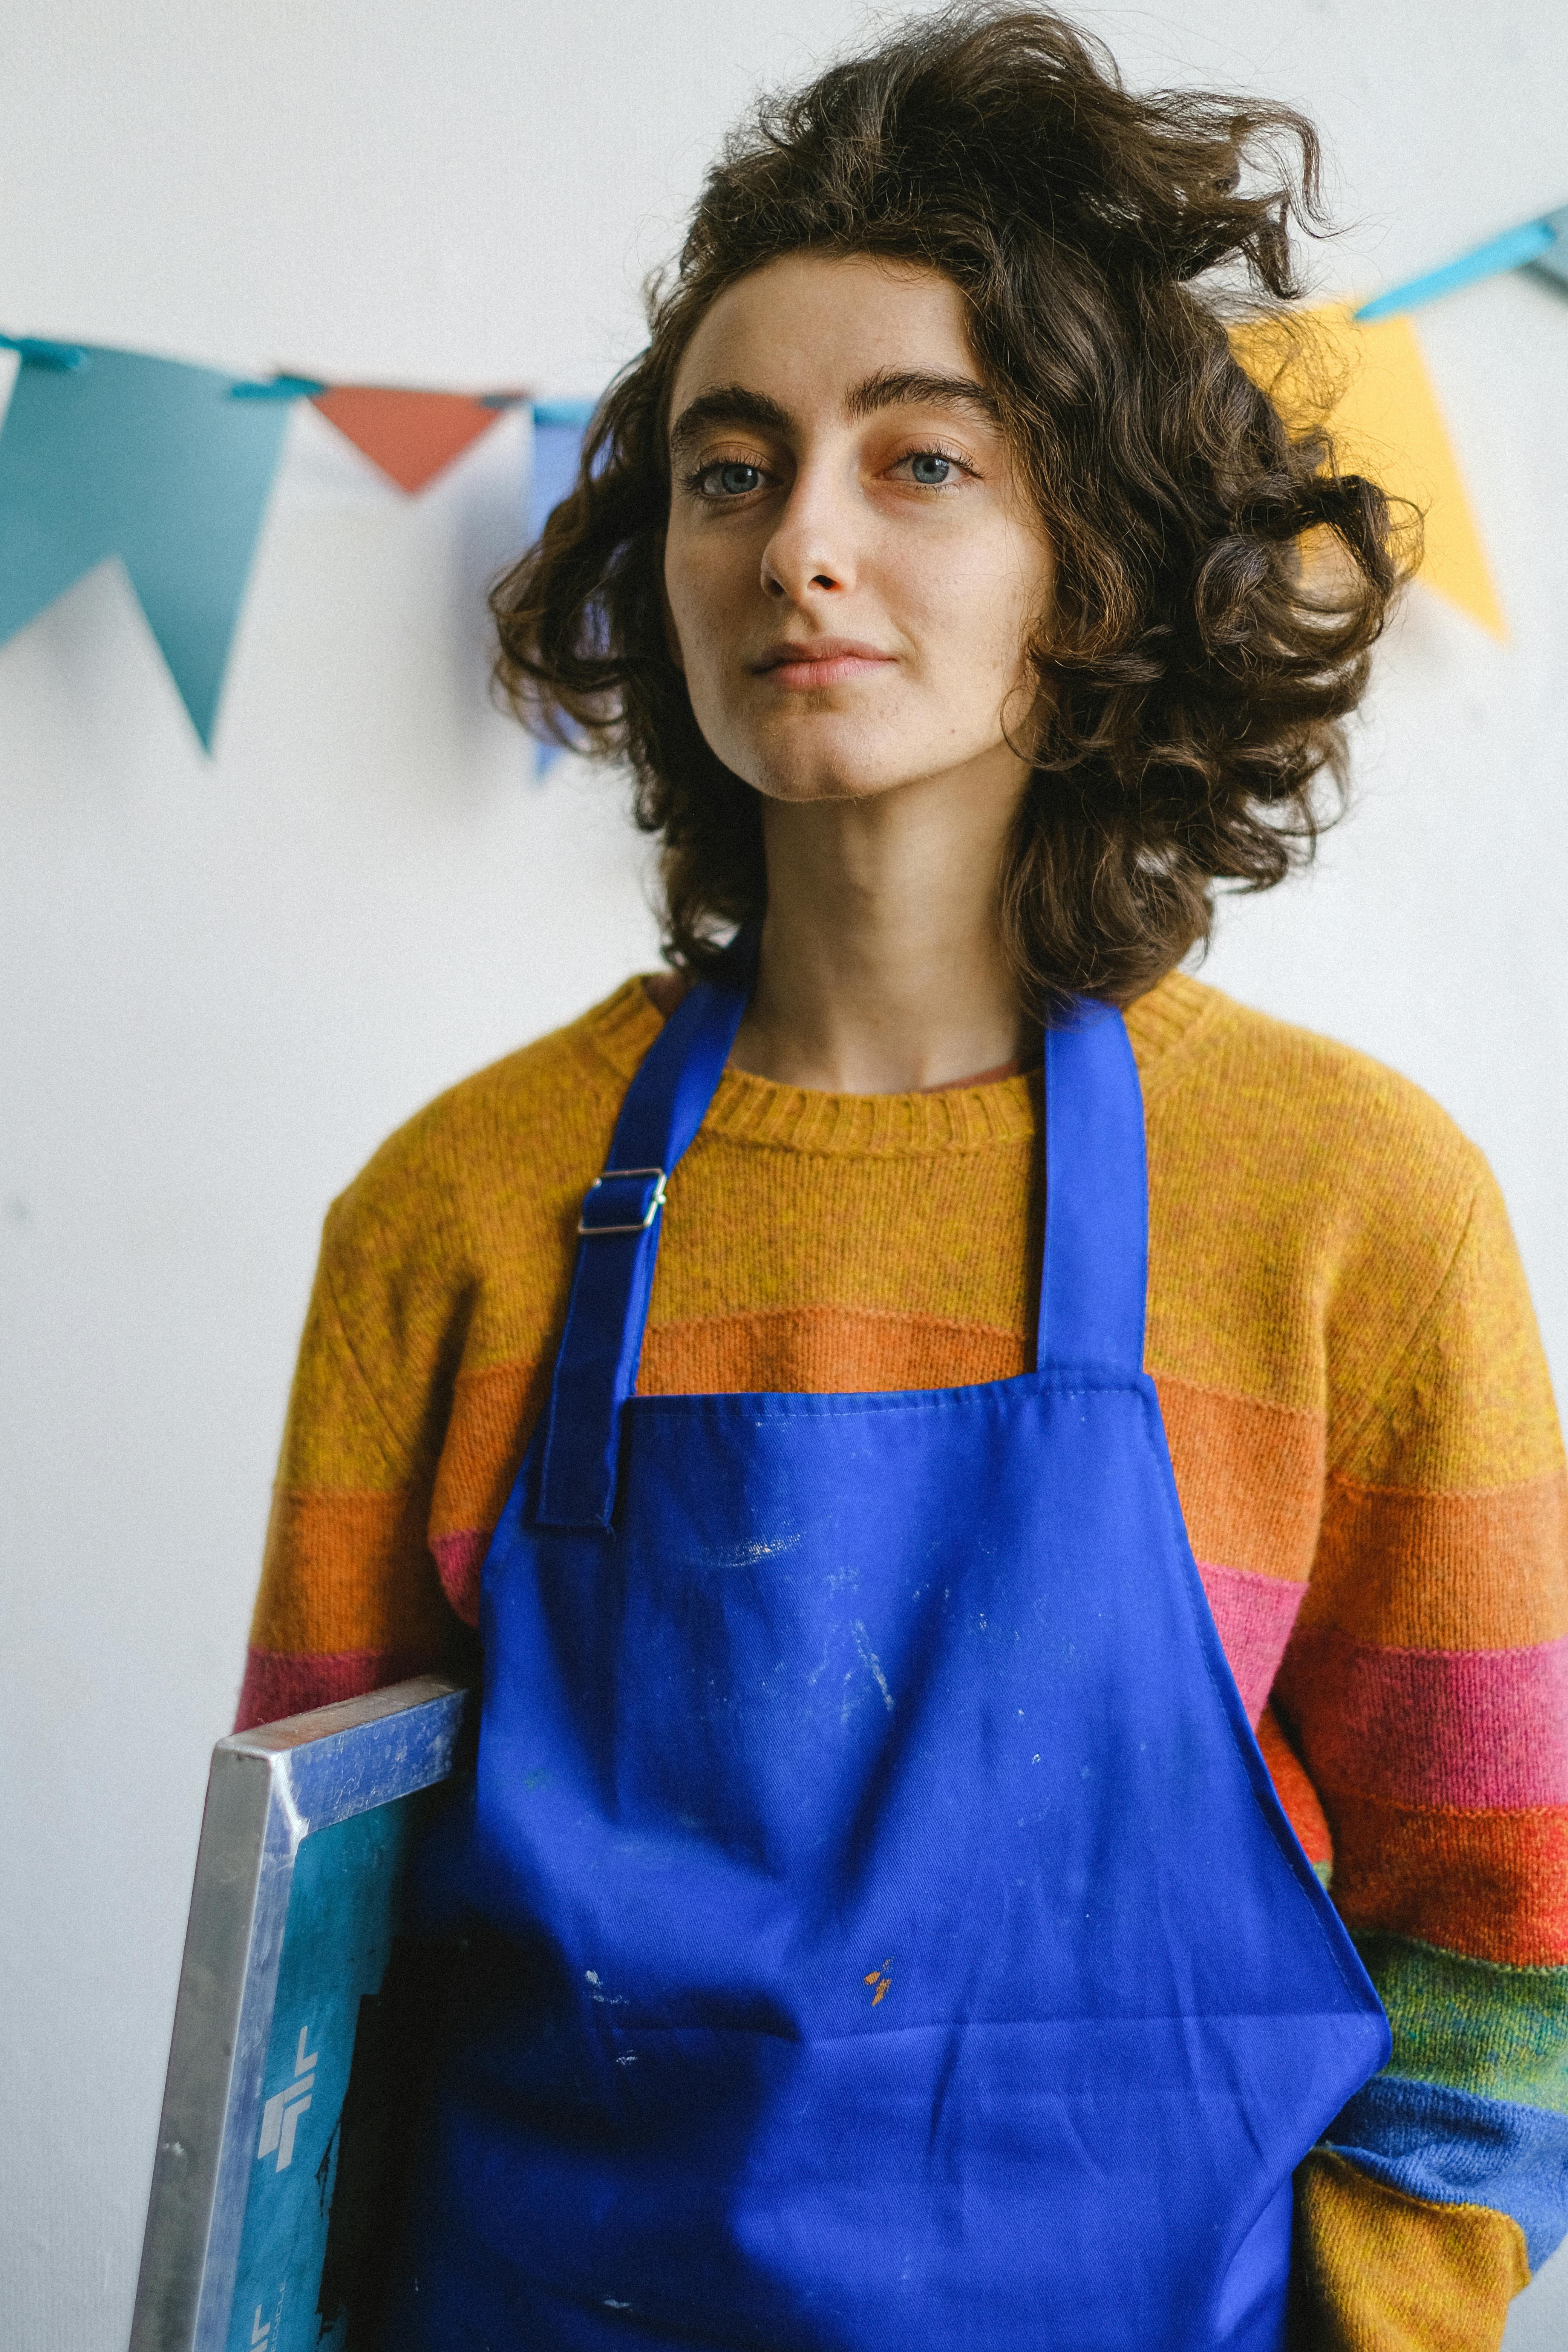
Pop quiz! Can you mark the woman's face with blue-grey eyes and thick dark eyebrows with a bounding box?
[665,254,1051,800]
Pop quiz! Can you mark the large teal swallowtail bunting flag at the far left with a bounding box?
[0,343,289,746]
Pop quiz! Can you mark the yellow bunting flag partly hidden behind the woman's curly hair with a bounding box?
[1232,303,1507,637]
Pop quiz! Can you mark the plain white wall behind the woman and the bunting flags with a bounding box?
[0,0,1568,2352]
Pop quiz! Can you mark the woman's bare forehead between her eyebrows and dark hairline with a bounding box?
[670,254,975,416]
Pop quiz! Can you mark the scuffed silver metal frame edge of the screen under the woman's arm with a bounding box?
[129,1675,475,2352]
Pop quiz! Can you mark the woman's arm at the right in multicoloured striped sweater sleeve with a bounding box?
[1277,1169,1568,2352]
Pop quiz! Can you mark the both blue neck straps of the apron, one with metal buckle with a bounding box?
[536,969,1150,1527]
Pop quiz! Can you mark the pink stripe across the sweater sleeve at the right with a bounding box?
[1279,1628,1568,1811]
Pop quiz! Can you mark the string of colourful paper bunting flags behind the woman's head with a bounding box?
[0,205,1568,748]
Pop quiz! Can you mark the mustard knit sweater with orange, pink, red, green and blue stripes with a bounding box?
[240,974,1568,2352]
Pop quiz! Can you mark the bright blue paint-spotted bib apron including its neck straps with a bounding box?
[388,981,1389,2352]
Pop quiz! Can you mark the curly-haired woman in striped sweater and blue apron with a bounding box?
[242,9,1568,2352]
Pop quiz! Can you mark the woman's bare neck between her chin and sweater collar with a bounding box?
[731,772,1027,1094]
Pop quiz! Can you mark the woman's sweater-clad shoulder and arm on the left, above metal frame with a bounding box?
[240,981,625,1729]
